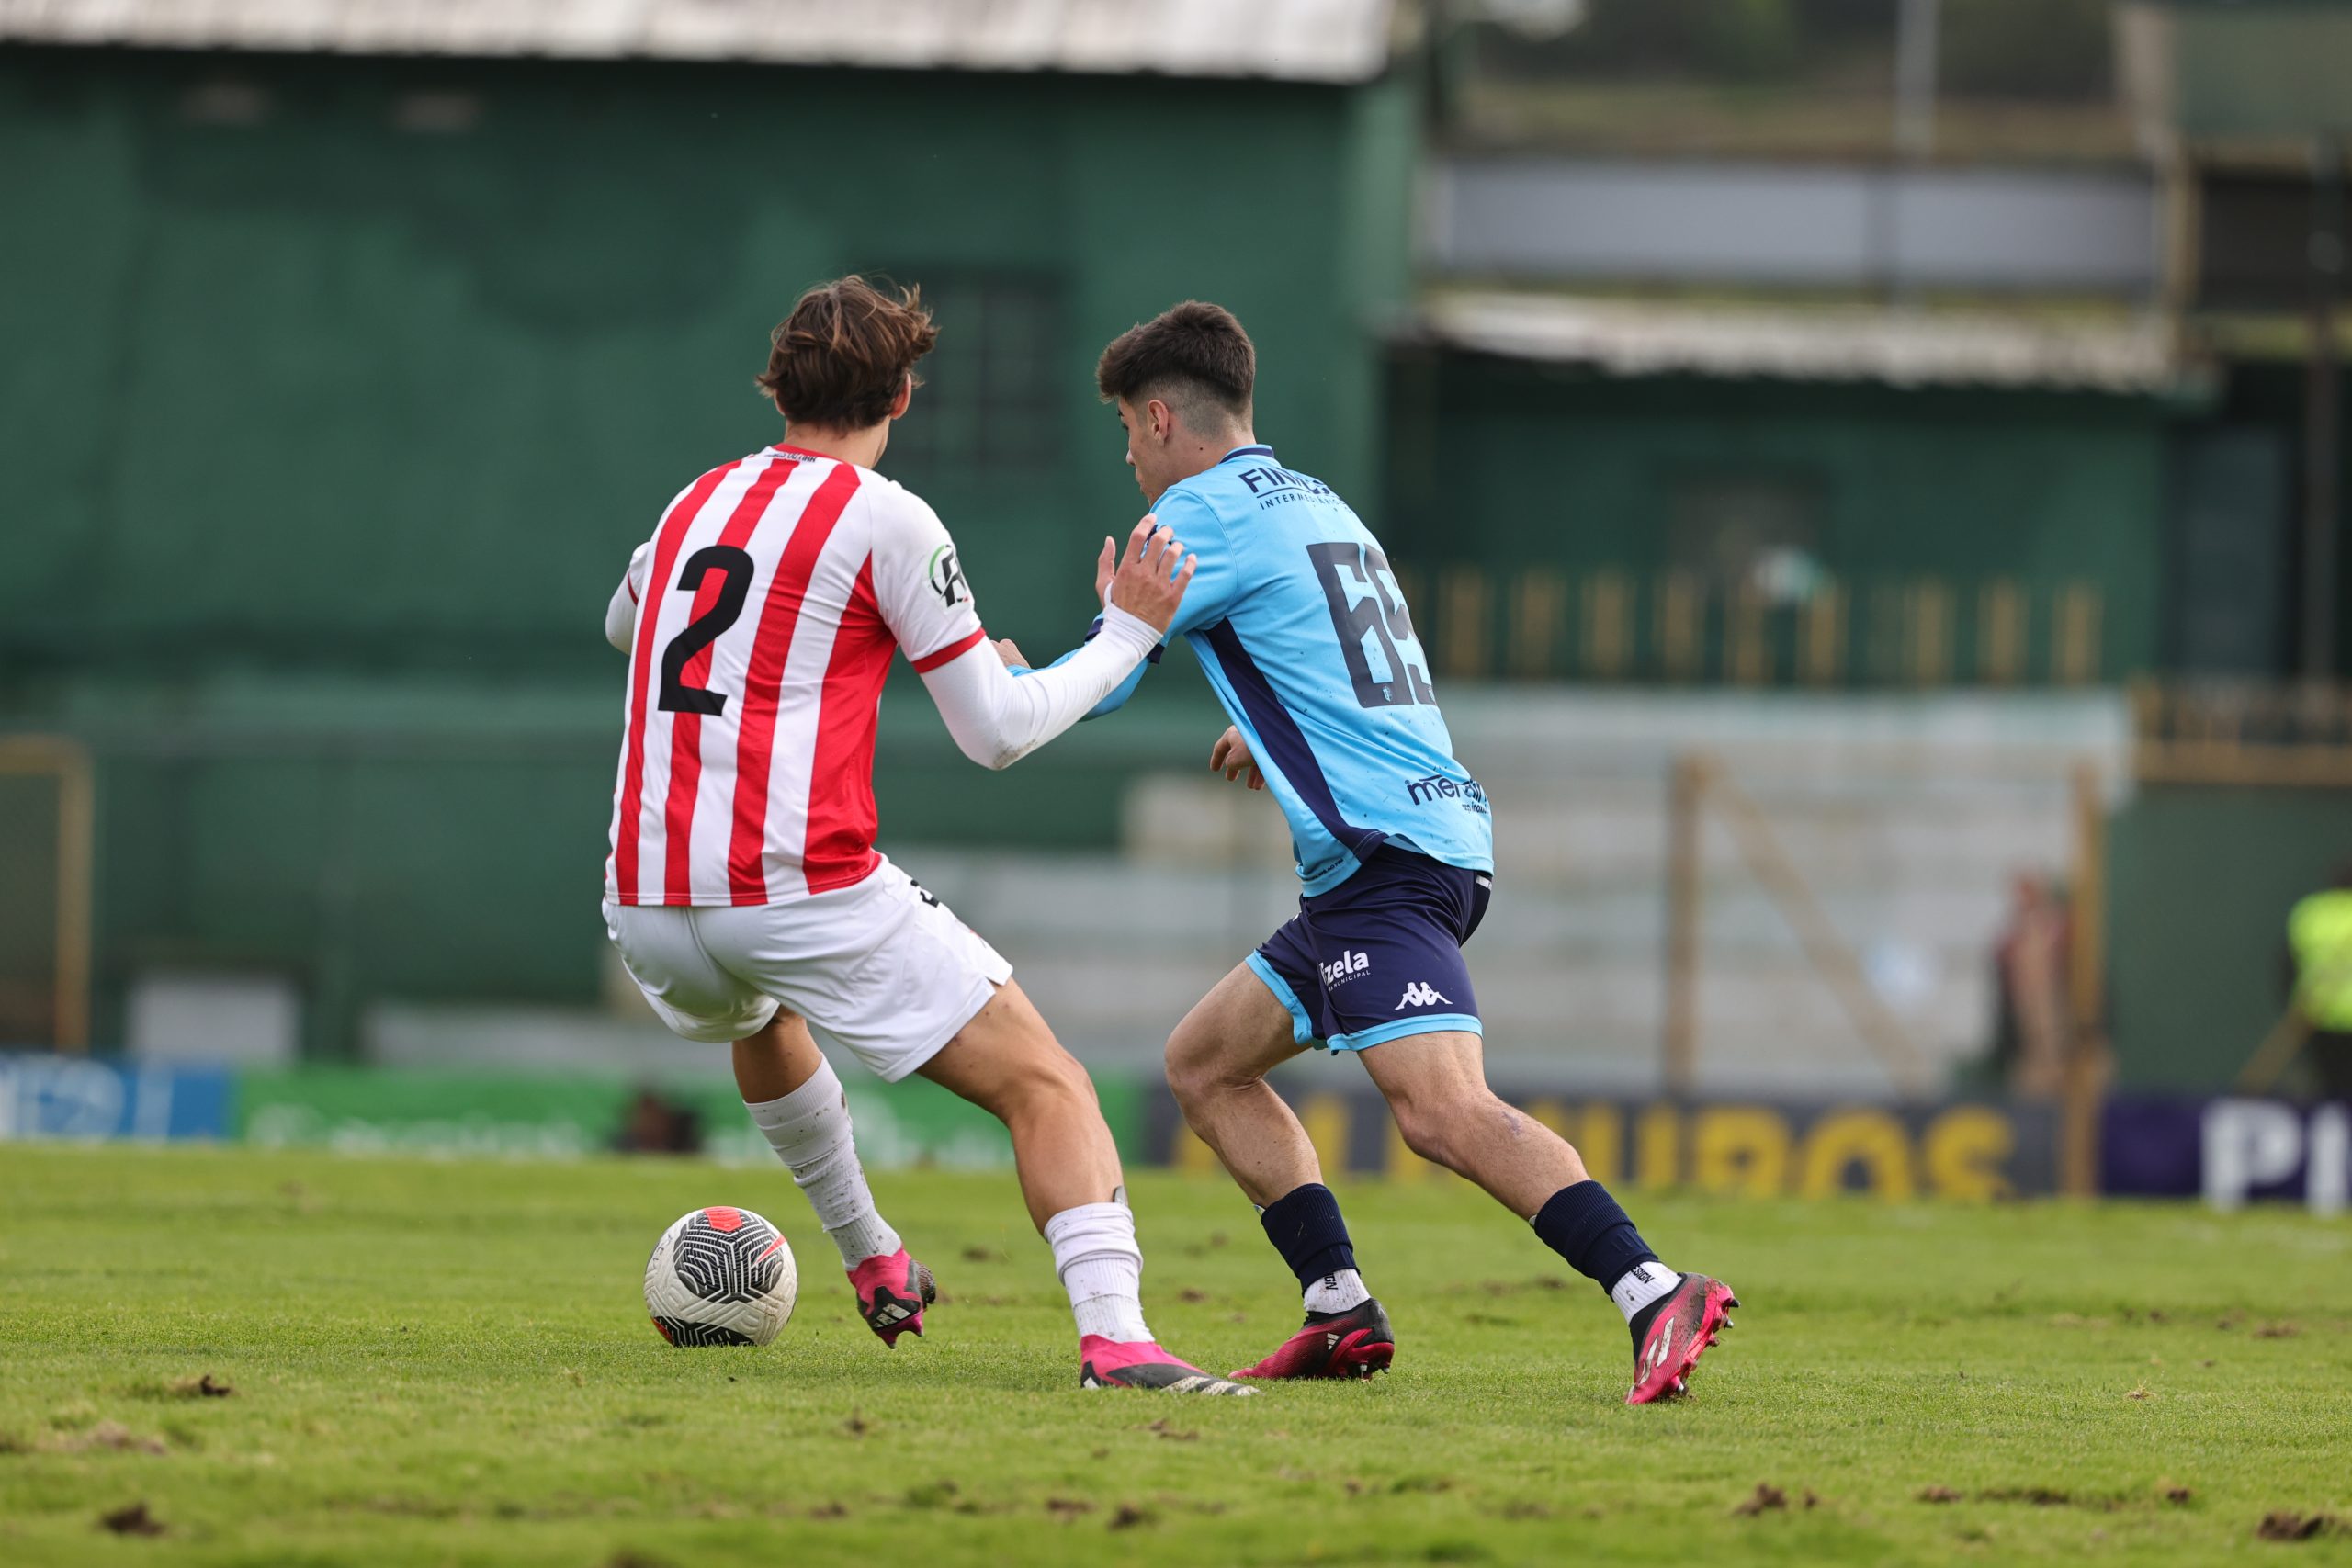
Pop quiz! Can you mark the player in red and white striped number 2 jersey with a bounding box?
[605,277,1249,1394]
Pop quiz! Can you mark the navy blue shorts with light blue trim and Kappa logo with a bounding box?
[1249,846,1494,1051]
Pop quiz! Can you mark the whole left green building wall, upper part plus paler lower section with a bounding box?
[0,50,1419,1058]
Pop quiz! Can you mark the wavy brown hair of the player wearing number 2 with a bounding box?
[760,273,938,430]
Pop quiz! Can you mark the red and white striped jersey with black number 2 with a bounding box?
[605,446,986,905]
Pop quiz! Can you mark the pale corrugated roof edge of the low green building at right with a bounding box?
[1420,294,2201,395]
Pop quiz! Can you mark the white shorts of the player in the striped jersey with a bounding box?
[605,858,1013,1084]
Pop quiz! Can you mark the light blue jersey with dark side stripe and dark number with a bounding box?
[1096,446,1494,898]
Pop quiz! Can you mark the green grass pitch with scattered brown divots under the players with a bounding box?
[0,1147,2352,1568]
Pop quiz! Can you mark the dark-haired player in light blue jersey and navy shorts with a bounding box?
[1021,301,1738,1404]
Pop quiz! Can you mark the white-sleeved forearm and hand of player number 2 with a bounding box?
[922,517,1194,769]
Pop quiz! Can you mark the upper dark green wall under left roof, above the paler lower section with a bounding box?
[0,50,1416,682]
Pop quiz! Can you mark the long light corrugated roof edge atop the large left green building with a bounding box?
[0,0,1395,83]
